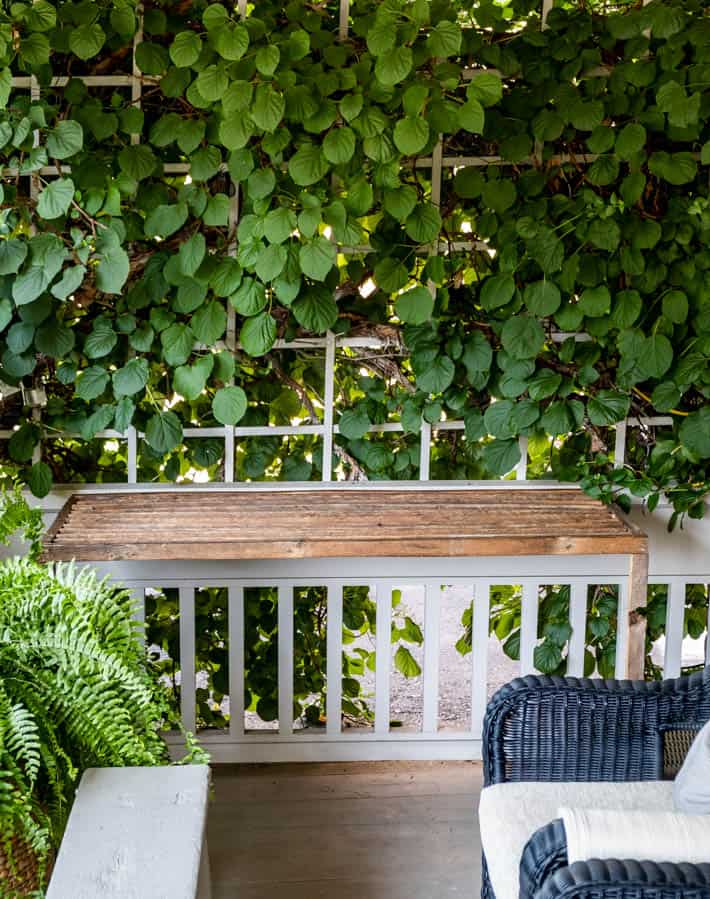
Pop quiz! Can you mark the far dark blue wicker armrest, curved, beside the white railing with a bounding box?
[483,668,710,785]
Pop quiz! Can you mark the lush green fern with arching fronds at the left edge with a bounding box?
[0,493,206,896]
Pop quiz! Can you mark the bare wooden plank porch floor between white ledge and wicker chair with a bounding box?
[208,762,481,899]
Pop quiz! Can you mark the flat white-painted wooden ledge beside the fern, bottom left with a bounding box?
[47,765,210,899]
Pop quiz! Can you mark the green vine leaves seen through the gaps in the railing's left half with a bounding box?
[145,587,424,728]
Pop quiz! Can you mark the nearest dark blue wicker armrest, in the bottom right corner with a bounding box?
[535,859,710,899]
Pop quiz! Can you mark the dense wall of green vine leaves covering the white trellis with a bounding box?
[0,0,710,516]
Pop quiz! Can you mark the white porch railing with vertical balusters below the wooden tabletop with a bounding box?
[97,557,710,762]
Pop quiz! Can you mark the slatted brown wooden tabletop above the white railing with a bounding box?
[44,487,647,561]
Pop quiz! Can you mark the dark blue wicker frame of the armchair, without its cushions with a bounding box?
[482,667,710,899]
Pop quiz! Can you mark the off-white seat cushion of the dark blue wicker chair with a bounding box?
[478,780,673,899]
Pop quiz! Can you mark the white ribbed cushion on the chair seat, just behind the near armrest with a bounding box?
[559,808,710,864]
